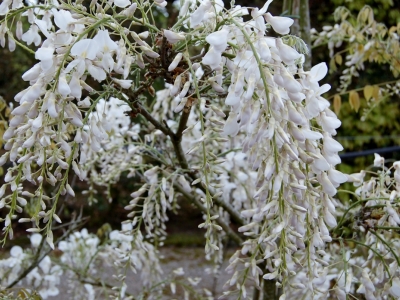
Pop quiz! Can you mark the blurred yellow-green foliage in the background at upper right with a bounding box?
[313,4,400,172]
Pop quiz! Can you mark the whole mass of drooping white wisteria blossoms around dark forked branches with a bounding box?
[0,0,400,299]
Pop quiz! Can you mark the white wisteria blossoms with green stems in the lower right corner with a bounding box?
[288,154,400,299]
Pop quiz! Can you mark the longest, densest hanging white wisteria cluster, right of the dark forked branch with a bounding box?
[148,1,347,294]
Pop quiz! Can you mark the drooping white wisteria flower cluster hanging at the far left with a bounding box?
[1,2,151,244]
